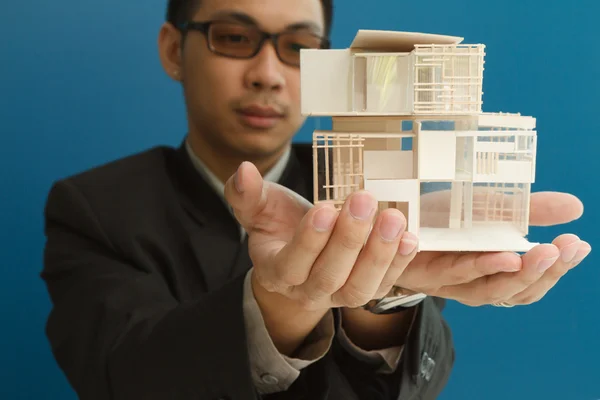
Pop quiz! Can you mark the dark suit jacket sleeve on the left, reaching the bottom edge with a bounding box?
[42,181,256,400]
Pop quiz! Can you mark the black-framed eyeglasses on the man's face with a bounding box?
[181,21,330,67]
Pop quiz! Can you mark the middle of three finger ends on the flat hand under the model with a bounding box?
[436,244,559,306]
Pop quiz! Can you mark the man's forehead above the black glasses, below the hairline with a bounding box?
[194,0,325,33]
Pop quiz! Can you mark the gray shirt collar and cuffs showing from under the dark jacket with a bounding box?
[186,142,402,394]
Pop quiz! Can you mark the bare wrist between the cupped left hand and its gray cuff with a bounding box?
[251,272,329,357]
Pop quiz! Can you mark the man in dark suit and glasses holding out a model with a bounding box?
[42,0,590,400]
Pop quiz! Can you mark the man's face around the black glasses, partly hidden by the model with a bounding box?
[182,0,324,158]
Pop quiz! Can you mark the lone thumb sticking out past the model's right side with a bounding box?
[529,192,583,226]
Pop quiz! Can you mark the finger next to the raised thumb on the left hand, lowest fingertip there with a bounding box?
[256,204,338,300]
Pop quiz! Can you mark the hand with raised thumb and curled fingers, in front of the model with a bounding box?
[225,163,416,310]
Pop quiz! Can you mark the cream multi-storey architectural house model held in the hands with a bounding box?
[301,30,536,252]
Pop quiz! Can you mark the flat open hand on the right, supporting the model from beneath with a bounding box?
[397,191,591,306]
